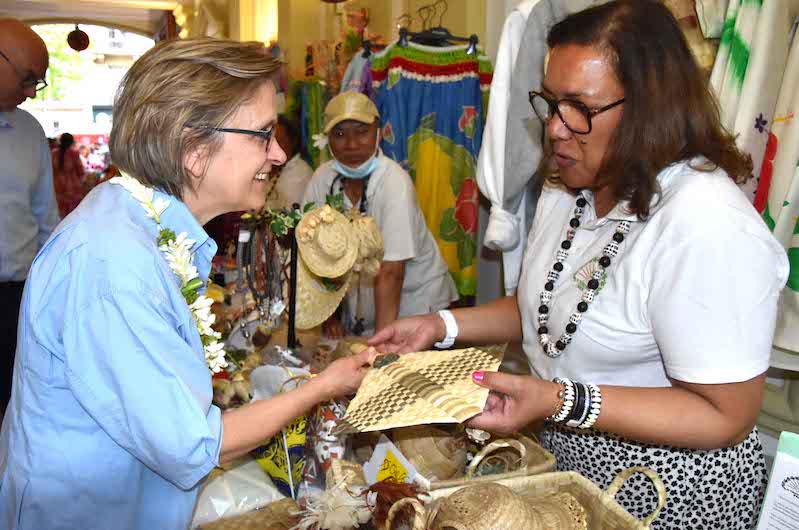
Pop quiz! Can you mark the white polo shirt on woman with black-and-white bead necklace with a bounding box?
[518,161,789,387]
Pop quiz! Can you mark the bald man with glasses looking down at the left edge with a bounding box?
[0,18,59,415]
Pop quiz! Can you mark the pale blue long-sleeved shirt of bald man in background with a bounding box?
[0,109,59,282]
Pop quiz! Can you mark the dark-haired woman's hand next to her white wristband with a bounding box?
[367,313,447,353]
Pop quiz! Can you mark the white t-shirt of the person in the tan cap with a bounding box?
[303,154,458,333]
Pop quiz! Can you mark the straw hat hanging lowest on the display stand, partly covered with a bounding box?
[295,253,352,329]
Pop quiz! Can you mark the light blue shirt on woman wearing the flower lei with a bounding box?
[0,179,222,530]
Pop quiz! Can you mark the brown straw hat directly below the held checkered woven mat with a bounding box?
[392,425,467,480]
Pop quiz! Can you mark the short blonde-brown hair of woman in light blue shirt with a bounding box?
[109,39,280,199]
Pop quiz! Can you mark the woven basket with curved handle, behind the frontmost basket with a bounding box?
[425,434,556,491]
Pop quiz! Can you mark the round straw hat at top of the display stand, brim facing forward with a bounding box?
[297,204,358,278]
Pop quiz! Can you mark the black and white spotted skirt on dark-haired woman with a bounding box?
[541,425,767,530]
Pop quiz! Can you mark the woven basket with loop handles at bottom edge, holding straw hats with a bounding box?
[386,467,666,530]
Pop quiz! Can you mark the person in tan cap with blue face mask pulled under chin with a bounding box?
[303,92,458,337]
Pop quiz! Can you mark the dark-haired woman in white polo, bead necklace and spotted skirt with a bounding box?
[371,0,788,529]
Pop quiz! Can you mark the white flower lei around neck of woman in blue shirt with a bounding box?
[110,174,227,373]
